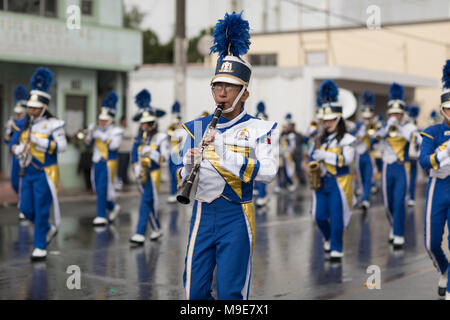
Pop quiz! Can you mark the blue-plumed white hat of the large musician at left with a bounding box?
[27,68,53,108]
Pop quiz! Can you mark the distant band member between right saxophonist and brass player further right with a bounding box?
[355,90,376,210]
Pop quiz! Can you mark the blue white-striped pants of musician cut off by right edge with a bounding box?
[424,177,450,292]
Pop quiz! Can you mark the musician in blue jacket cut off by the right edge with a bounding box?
[419,60,450,300]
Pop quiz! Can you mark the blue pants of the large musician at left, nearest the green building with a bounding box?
[19,165,53,250]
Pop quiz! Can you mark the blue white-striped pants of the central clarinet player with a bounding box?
[183,197,254,300]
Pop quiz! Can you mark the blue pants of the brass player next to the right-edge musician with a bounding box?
[383,162,408,237]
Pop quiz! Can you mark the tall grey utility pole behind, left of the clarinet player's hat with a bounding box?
[174,0,187,118]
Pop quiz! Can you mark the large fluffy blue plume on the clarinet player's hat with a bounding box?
[210,12,250,61]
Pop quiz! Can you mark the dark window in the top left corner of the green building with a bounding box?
[5,0,58,17]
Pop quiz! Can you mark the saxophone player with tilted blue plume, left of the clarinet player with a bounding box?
[130,89,170,245]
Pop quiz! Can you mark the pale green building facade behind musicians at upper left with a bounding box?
[0,0,142,189]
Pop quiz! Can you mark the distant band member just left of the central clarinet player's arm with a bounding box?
[167,101,187,203]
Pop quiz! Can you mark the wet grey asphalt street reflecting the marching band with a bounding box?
[0,184,448,300]
